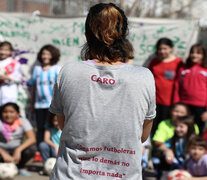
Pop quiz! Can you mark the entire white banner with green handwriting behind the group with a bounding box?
[0,13,198,116]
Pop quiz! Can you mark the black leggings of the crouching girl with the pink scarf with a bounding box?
[0,144,37,168]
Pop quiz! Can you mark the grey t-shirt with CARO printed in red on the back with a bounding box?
[50,62,156,180]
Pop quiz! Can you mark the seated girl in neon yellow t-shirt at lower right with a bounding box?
[151,103,199,179]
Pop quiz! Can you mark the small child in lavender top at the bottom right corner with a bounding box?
[183,136,207,180]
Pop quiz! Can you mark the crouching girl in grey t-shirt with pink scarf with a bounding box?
[0,103,36,176]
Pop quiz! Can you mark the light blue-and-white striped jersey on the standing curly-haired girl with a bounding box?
[29,65,60,109]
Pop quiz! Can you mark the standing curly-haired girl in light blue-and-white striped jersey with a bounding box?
[30,45,60,145]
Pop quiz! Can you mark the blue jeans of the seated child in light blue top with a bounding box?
[39,142,56,163]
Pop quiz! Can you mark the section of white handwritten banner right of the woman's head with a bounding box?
[129,19,199,65]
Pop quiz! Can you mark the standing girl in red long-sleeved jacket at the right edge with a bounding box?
[174,44,207,134]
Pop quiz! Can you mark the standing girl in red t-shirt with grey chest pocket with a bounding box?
[149,38,182,136]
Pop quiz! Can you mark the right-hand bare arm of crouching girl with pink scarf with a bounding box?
[13,129,36,163]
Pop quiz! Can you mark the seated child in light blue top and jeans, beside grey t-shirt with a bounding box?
[39,116,62,163]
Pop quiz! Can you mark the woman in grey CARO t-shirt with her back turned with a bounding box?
[50,3,156,180]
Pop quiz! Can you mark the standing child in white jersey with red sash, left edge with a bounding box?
[0,41,22,106]
